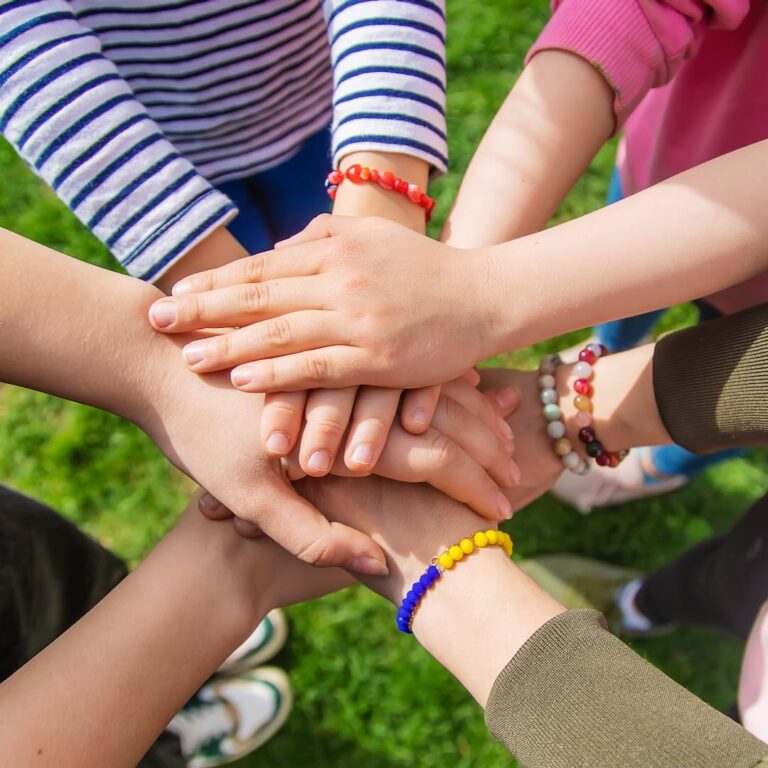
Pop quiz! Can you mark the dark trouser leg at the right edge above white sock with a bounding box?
[635,488,768,639]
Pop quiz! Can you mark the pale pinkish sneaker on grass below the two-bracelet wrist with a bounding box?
[552,448,688,515]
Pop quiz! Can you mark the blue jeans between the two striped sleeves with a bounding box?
[219,128,331,253]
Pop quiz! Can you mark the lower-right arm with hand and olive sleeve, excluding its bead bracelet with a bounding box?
[303,478,768,768]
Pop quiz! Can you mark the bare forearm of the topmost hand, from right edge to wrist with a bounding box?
[484,142,768,355]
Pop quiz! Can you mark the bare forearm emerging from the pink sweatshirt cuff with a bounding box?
[440,51,614,248]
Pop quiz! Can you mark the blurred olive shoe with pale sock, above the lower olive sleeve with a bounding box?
[518,554,675,637]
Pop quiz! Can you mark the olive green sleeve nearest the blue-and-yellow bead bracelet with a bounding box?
[485,610,768,768]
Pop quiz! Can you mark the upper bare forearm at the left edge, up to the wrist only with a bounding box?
[0,225,161,419]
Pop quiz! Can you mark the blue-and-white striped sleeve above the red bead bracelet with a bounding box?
[324,0,448,172]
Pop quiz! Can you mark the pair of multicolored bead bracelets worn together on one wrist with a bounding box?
[539,344,629,475]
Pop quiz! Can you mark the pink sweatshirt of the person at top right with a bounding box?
[528,0,768,312]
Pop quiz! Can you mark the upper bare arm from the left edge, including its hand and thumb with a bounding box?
[0,225,390,573]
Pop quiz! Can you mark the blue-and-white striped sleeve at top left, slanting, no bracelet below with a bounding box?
[0,0,237,280]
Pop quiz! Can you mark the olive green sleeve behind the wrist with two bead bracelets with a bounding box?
[653,304,768,453]
